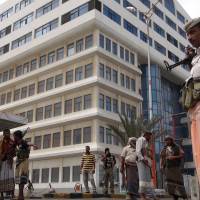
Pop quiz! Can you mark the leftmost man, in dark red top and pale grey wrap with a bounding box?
[0,129,15,198]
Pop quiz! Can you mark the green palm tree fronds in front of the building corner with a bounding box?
[108,113,162,146]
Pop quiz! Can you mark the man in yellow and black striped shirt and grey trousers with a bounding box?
[81,146,96,193]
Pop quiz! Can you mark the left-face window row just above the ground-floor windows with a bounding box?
[26,126,92,151]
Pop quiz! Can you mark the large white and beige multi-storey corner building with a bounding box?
[0,0,192,189]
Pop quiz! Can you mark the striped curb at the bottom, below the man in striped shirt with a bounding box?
[43,193,170,199]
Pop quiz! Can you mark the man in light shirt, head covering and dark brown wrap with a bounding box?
[120,137,138,200]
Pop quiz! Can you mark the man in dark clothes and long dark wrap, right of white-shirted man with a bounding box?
[160,135,187,200]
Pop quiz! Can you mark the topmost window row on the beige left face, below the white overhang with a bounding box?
[0,34,93,83]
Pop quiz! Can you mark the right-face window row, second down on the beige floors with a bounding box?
[99,63,136,92]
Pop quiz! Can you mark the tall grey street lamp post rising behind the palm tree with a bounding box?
[126,0,161,186]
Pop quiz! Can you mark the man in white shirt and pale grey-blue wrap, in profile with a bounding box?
[136,130,157,200]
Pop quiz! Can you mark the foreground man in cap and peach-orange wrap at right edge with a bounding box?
[185,17,200,183]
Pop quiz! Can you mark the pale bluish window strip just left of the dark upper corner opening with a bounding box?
[35,18,58,38]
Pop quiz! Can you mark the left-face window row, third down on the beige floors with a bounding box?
[20,94,92,122]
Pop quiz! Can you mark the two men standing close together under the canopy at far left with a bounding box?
[0,129,31,200]
